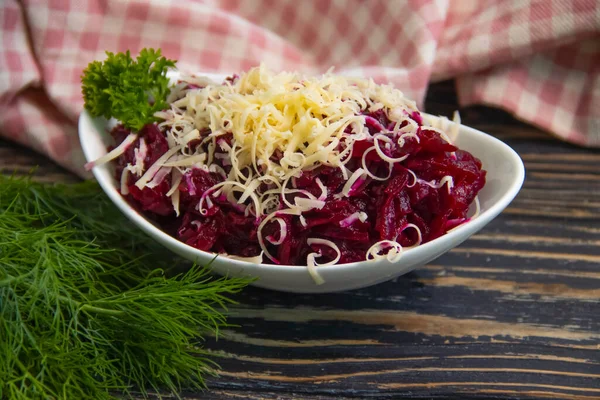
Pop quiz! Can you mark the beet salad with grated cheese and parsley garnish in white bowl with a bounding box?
[83,50,518,294]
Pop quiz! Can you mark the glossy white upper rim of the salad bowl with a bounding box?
[78,110,525,273]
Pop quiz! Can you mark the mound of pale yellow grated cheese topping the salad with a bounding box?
[157,66,416,207]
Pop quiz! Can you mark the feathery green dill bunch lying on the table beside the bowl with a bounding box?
[0,175,248,399]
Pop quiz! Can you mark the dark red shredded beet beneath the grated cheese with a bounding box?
[112,111,486,265]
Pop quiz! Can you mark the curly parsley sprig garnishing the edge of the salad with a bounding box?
[81,49,175,131]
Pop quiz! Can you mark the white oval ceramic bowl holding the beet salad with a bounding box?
[79,78,525,293]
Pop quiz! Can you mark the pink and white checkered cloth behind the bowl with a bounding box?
[0,0,600,174]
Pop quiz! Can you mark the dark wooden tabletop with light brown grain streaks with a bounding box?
[0,83,600,399]
